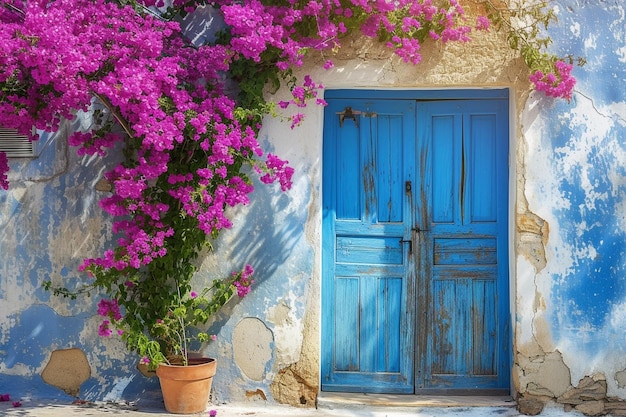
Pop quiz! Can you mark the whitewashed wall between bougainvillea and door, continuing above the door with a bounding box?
[202,8,529,406]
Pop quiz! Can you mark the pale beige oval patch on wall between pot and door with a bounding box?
[233,317,274,381]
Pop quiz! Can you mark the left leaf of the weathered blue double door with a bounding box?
[322,100,415,393]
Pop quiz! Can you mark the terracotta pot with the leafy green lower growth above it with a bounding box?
[91,265,253,414]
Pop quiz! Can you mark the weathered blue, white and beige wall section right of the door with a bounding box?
[516,0,626,415]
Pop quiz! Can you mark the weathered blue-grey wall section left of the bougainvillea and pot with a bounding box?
[0,112,161,399]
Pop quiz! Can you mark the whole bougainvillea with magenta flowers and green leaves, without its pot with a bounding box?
[0,0,574,366]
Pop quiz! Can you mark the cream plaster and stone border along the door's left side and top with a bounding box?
[252,9,529,406]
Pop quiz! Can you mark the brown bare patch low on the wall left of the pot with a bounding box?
[41,348,91,397]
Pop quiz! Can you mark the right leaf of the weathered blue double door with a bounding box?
[416,100,510,392]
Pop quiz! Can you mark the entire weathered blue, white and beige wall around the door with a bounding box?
[0,0,626,415]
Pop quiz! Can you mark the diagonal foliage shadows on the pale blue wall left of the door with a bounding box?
[190,165,313,334]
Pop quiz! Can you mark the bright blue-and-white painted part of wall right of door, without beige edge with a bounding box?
[529,1,626,356]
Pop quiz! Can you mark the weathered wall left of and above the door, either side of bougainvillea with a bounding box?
[0,2,528,406]
